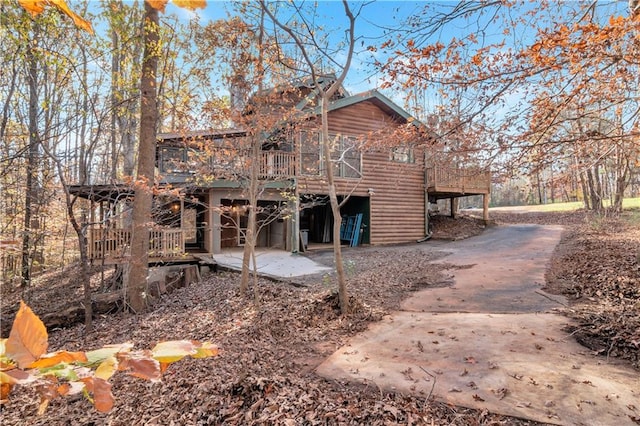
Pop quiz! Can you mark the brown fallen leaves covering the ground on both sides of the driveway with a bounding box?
[0,208,640,425]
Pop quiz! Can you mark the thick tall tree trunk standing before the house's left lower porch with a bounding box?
[126,2,159,313]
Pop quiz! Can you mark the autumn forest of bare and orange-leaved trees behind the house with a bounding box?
[0,0,640,290]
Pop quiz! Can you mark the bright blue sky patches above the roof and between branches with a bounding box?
[152,0,627,119]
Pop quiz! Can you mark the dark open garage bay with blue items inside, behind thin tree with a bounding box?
[300,194,371,245]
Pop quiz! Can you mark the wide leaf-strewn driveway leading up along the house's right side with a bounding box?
[317,225,640,425]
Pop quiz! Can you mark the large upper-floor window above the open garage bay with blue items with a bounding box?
[300,132,362,178]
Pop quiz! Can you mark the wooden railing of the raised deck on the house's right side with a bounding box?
[427,167,491,192]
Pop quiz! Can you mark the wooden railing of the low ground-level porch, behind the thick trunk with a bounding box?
[87,228,185,260]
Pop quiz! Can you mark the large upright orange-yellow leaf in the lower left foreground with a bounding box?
[5,301,48,368]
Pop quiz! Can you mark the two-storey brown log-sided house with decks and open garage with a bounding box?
[71,78,491,263]
